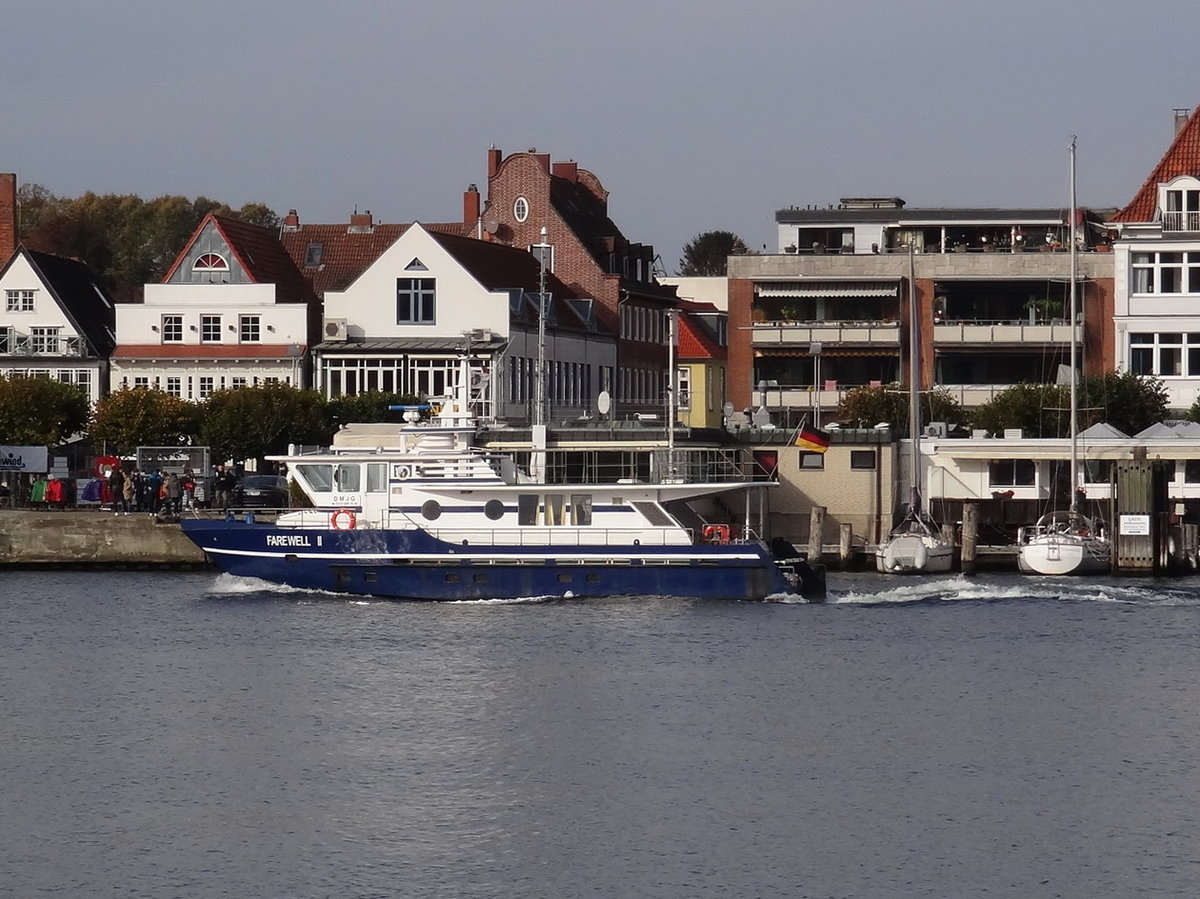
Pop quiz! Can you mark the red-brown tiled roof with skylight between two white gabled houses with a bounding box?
[280,222,466,296]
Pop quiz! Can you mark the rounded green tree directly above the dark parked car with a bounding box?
[200,382,329,460]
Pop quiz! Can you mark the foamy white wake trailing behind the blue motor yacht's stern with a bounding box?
[827,575,1200,605]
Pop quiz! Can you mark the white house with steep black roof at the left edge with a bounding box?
[0,247,114,402]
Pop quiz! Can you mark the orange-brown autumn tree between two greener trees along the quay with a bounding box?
[89,388,200,455]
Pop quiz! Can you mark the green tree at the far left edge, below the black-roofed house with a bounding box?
[0,376,88,446]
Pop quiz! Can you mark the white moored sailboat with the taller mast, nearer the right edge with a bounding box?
[1016,139,1112,575]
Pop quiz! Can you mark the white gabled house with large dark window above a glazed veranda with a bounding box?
[304,221,616,421]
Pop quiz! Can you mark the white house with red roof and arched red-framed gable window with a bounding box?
[112,215,316,400]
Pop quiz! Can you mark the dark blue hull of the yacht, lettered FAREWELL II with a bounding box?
[181,519,823,601]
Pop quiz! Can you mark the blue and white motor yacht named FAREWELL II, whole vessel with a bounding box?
[181,381,824,600]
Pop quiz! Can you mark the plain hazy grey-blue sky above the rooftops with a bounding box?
[0,0,1200,274]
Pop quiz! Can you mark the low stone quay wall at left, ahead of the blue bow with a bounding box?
[0,509,206,568]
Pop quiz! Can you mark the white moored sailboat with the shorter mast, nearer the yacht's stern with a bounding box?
[875,242,954,574]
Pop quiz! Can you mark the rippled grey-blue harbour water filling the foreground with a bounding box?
[0,571,1200,899]
